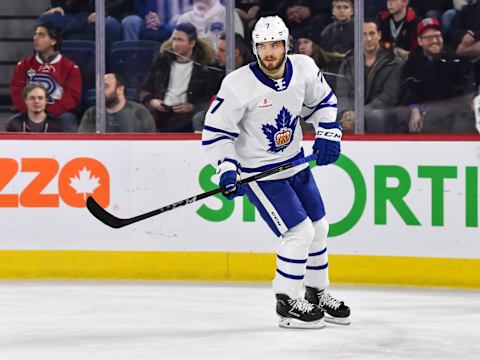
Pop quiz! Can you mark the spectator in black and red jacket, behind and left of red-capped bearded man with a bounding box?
[377,0,420,60]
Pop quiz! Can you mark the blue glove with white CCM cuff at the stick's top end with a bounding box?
[313,122,343,165]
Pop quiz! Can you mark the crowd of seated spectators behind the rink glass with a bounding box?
[7,0,480,133]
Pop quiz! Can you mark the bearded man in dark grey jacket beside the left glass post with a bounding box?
[78,74,155,133]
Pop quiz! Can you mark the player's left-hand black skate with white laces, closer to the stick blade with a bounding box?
[276,294,325,329]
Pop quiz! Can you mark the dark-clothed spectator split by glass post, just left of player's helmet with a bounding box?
[192,34,251,132]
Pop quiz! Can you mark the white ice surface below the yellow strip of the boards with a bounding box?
[0,282,480,360]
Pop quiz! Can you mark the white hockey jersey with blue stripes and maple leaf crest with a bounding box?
[202,55,337,179]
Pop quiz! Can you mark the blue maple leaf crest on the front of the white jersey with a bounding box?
[262,107,299,152]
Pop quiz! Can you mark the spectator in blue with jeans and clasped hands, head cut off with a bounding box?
[122,0,178,42]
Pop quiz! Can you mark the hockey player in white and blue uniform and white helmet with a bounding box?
[202,16,350,328]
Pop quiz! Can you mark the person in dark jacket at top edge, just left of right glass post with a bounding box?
[320,0,355,54]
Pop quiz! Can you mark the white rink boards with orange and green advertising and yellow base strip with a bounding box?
[0,135,480,288]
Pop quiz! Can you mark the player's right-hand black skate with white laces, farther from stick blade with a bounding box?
[305,286,350,325]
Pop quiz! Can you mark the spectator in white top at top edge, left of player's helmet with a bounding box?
[177,0,245,49]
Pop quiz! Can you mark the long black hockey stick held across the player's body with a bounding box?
[87,154,317,229]
